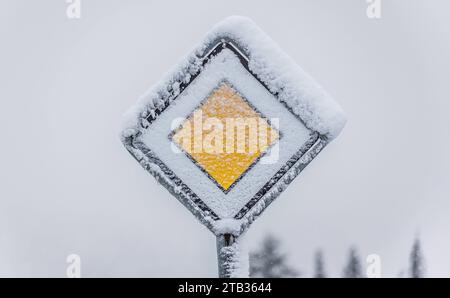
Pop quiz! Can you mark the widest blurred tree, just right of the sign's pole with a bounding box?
[250,235,299,278]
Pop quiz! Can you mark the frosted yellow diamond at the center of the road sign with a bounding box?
[172,83,279,191]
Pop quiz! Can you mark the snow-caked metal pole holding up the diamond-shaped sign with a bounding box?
[217,234,249,278]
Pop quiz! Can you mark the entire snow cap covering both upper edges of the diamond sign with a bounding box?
[122,16,346,140]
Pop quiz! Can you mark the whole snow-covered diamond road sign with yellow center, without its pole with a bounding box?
[122,17,345,237]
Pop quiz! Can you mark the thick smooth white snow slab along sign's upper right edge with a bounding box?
[202,16,346,139]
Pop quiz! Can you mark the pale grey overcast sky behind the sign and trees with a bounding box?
[0,0,450,277]
